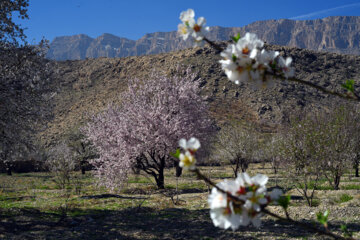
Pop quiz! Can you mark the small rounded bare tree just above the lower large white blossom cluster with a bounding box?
[214,122,258,177]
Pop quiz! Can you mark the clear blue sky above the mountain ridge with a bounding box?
[17,0,360,43]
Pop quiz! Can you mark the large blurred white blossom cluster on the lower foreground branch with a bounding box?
[208,173,272,230]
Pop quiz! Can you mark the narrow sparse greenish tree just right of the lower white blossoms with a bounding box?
[279,112,325,207]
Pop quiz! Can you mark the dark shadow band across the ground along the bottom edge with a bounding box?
[0,208,360,240]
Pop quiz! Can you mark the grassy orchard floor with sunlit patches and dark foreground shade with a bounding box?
[0,164,360,240]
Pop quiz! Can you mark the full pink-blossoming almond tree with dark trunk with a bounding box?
[84,70,213,188]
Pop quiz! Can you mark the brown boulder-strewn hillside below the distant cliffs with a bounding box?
[43,42,360,143]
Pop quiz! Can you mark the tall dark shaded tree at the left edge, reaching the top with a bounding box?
[0,0,52,174]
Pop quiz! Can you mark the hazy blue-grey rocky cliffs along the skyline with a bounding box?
[47,16,360,60]
